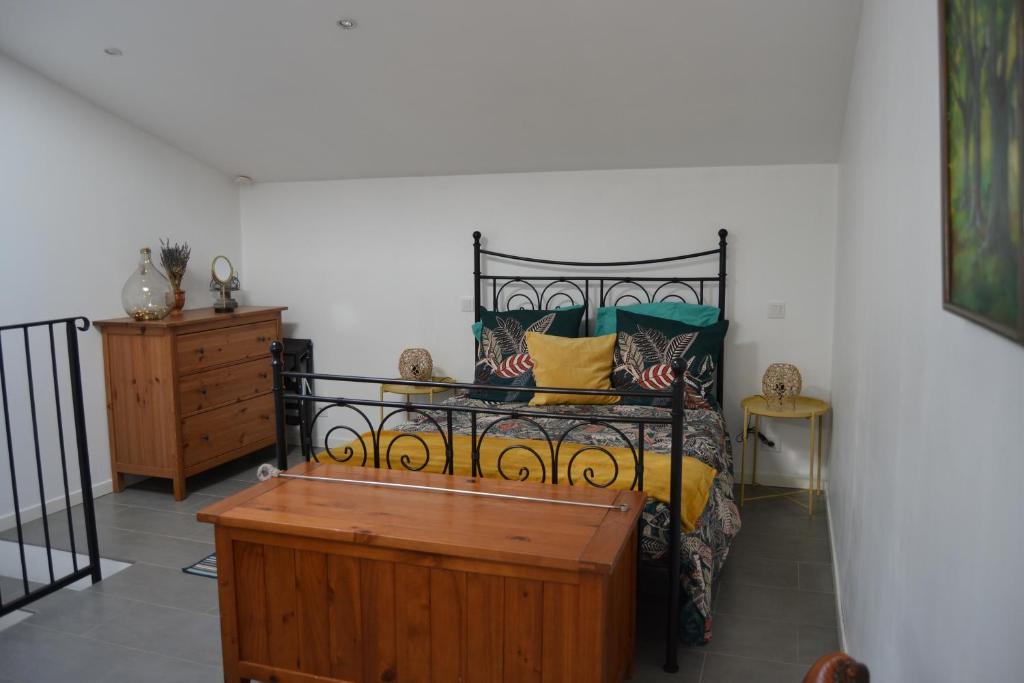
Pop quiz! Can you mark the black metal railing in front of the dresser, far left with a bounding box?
[0,316,100,615]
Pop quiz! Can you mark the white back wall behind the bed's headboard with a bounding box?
[242,165,836,480]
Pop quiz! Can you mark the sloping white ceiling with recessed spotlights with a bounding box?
[0,0,860,180]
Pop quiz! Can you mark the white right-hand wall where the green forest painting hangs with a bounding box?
[828,0,1024,682]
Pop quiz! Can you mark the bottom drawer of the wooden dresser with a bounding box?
[181,394,273,467]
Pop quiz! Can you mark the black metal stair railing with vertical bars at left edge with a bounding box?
[0,316,100,615]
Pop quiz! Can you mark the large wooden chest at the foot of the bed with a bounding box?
[199,463,644,683]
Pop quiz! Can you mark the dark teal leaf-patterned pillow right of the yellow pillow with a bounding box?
[611,310,729,410]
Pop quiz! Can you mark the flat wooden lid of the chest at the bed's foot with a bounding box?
[198,463,646,573]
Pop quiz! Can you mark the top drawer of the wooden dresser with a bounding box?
[177,321,278,375]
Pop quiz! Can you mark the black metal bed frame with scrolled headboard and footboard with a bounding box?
[270,229,728,673]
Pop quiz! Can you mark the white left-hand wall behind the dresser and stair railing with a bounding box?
[0,55,241,526]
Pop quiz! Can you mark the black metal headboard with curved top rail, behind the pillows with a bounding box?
[473,228,729,405]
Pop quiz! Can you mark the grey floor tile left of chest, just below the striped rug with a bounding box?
[89,556,217,614]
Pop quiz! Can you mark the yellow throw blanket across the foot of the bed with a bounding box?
[316,431,718,532]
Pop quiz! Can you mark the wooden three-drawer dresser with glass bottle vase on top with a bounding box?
[95,306,286,501]
